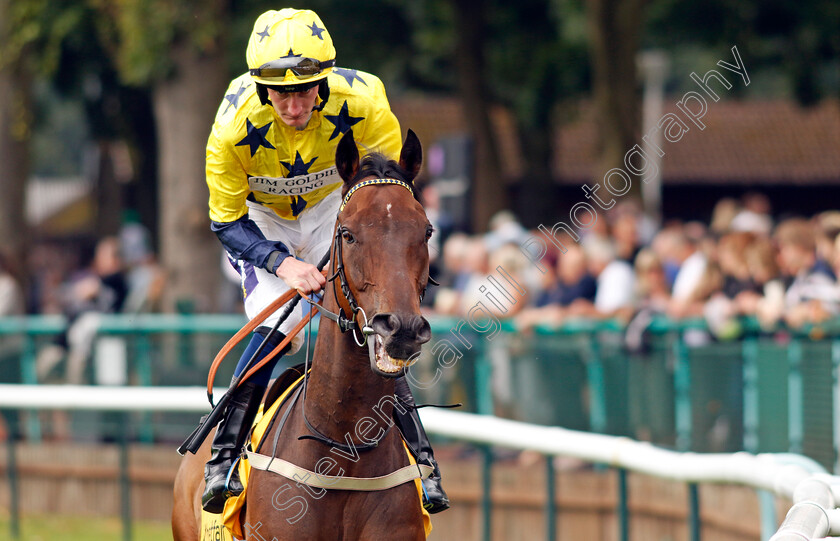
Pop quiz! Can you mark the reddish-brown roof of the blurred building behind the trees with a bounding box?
[392,97,840,185]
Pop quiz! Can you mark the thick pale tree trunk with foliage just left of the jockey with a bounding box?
[98,0,229,311]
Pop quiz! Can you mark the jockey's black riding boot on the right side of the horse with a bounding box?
[394,377,449,513]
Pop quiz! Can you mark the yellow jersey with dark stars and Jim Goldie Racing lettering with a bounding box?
[206,68,402,223]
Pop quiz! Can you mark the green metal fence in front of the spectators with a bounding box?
[0,315,840,470]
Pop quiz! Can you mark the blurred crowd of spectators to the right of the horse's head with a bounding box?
[428,193,840,338]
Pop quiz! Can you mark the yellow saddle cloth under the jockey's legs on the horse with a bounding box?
[199,376,432,541]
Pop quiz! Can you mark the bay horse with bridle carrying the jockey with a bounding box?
[172,130,433,541]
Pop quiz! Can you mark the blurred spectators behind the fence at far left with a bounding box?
[0,215,164,384]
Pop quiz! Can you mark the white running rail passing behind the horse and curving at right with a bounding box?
[0,385,840,541]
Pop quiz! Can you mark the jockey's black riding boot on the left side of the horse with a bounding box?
[201,381,263,514]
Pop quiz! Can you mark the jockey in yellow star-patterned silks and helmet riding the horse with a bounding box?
[202,8,449,513]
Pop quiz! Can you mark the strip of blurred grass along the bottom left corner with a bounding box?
[0,514,172,541]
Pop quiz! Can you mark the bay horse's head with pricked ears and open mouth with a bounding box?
[331,130,433,377]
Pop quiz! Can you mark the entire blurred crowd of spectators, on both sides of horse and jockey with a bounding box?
[0,186,840,383]
